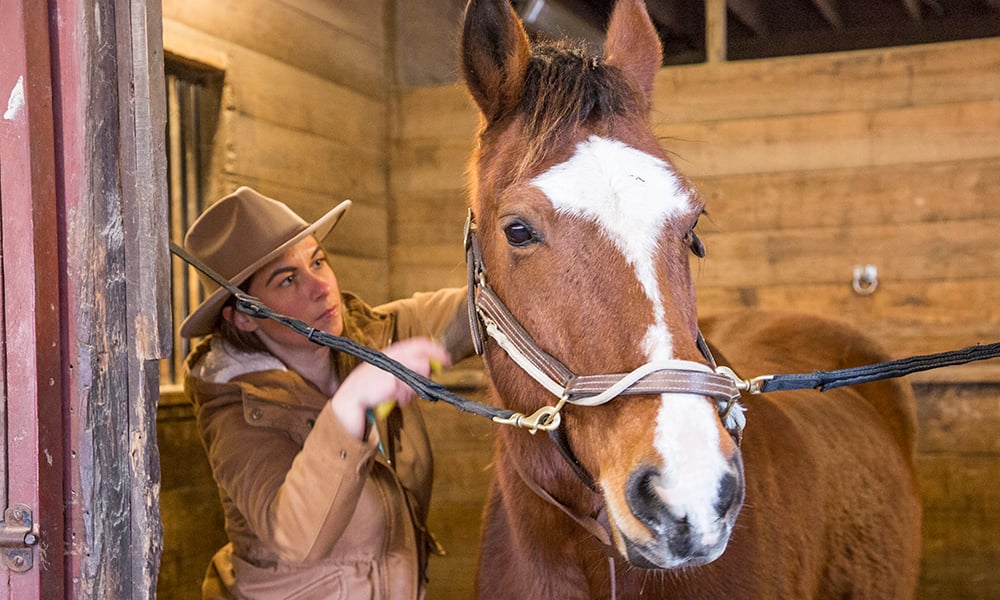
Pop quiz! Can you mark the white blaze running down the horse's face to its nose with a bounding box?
[532,136,728,543]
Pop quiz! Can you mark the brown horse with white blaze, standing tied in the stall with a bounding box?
[462,0,920,600]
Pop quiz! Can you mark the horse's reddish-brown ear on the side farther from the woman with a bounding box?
[604,0,663,99]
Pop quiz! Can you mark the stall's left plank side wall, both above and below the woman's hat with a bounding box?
[157,0,391,599]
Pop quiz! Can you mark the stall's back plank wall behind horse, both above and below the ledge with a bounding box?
[390,39,1000,598]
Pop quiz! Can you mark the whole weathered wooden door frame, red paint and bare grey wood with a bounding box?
[0,0,170,600]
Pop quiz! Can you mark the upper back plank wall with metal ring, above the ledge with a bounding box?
[390,39,1000,370]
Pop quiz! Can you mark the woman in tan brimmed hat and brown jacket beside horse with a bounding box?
[181,187,472,599]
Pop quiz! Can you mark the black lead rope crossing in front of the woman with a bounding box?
[170,242,514,419]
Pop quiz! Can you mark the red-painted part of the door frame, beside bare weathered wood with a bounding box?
[0,0,65,599]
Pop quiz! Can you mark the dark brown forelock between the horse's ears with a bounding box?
[483,40,648,175]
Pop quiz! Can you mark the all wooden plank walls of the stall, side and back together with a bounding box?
[150,0,1000,598]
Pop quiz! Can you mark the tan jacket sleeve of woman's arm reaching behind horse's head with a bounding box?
[376,287,475,362]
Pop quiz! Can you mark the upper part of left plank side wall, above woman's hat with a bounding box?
[163,0,391,302]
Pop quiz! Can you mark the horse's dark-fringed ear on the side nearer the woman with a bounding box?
[461,0,531,122]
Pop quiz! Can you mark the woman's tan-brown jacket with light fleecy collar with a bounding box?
[184,289,468,599]
